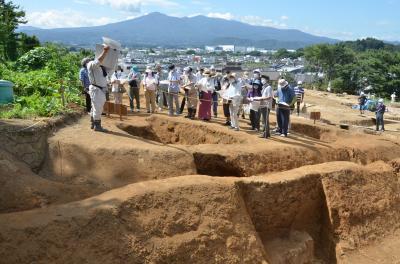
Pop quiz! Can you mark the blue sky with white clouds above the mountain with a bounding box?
[12,0,400,41]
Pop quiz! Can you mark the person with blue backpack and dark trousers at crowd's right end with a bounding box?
[276,79,295,137]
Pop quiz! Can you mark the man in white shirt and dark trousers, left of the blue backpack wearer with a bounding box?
[254,75,274,138]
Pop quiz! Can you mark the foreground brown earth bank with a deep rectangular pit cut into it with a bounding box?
[0,162,400,263]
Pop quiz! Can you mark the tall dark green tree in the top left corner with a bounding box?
[0,0,27,60]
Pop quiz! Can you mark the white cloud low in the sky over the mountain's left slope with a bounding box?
[27,9,116,28]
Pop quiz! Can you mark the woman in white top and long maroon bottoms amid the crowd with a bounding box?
[197,70,214,121]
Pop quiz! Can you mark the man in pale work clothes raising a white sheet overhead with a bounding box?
[87,45,110,132]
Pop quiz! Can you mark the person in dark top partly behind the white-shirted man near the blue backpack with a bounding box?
[247,69,262,131]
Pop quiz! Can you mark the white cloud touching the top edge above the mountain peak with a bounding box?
[92,0,180,13]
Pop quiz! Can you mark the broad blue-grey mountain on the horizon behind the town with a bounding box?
[20,12,337,49]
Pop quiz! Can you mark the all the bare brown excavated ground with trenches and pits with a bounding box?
[0,90,400,264]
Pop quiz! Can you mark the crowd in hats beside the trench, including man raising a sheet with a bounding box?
[80,46,304,138]
